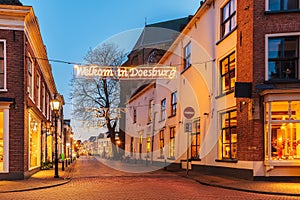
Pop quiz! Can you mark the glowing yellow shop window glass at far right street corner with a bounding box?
[265,101,300,160]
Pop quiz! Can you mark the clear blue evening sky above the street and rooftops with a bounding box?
[20,0,200,139]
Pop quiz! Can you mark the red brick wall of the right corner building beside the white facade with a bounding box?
[237,0,300,161]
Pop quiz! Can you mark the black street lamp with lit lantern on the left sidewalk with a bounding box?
[50,94,60,178]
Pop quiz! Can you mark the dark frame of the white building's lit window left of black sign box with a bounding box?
[219,50,236,95]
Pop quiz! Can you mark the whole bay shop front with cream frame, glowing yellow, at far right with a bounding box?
[264,91,300,176]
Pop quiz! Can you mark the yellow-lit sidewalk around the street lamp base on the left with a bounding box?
[0,161,76,193]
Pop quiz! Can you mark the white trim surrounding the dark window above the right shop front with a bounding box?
[265,32,300,81]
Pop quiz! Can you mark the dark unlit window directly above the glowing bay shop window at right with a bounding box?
[268,36,299,80]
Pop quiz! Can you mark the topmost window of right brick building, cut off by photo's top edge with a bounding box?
[268,0,299,11]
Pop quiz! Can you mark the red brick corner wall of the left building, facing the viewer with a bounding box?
[0,30,27,173]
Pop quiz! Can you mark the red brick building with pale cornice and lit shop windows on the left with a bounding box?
[0,1,63,179]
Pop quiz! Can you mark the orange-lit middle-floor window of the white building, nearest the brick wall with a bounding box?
[220,52,235,93]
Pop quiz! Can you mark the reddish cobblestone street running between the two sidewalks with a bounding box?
[0,156,299,200]
